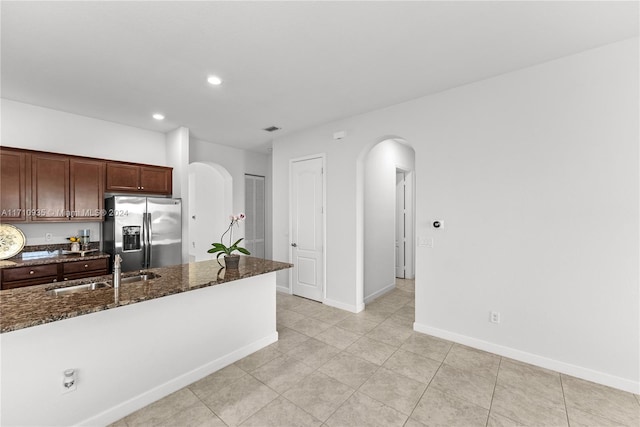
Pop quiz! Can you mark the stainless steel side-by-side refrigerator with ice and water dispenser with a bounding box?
[102,196,182,271]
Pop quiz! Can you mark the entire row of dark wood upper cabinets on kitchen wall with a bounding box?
[0,147,173,222]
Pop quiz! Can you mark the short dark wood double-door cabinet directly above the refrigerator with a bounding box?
[106,162,173,195]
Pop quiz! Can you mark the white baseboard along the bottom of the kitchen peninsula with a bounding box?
[78,331,278,426]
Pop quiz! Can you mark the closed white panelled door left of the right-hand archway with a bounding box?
[290,157,324,301]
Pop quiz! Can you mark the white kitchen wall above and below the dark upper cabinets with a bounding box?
[0,99,169,245]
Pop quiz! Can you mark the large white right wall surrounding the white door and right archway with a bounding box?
[273,38,640,393]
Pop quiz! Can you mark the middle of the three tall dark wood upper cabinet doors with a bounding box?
[30,154,69,221]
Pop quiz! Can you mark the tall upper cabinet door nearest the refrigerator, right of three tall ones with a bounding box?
[69,157,105,221]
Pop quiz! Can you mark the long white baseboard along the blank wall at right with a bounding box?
[413,323,640,394]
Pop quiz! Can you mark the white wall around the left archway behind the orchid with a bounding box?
[189,138,272,261]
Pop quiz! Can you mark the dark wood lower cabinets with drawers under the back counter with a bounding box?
[0,258,109,290]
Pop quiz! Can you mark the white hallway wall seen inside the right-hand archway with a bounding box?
[364,139,415,302]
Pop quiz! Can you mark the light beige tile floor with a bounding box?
[113,280,640,427]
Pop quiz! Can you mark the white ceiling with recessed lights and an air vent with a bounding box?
[0,1,639,151]
